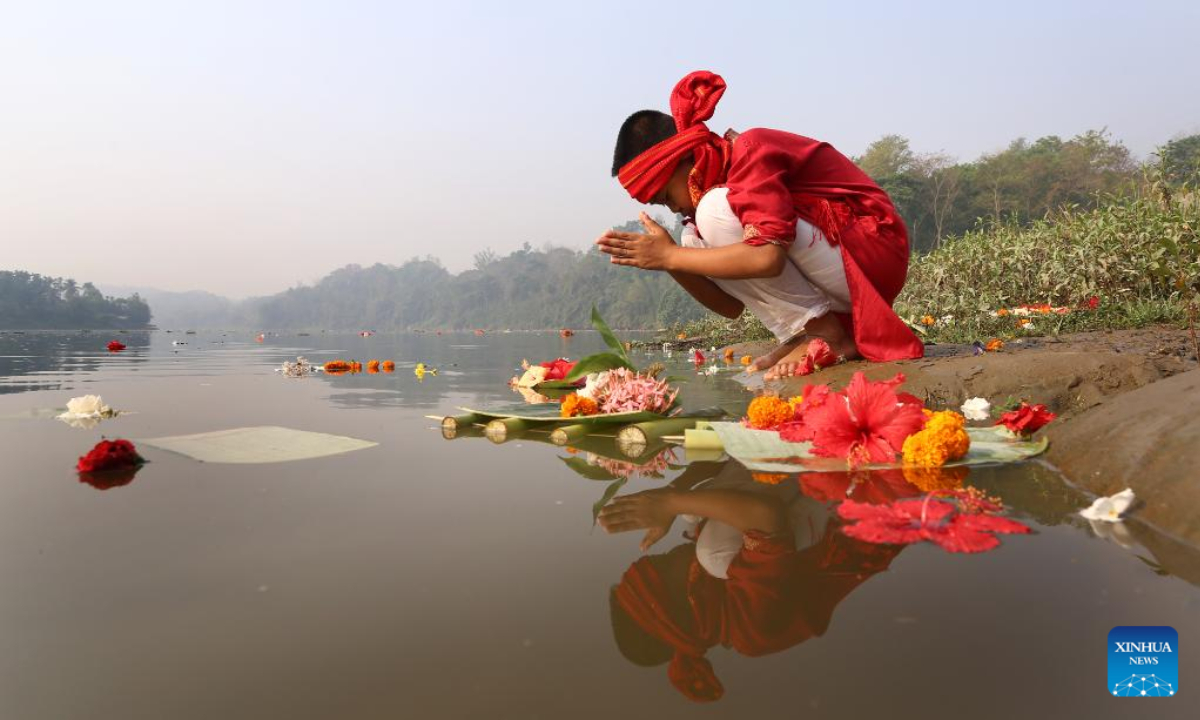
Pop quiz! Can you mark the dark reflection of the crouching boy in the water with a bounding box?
[600,463,900,702]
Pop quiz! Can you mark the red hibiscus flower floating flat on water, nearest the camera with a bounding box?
[838,496,1031,552]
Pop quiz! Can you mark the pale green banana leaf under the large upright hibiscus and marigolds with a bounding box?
[688,422,1049,473]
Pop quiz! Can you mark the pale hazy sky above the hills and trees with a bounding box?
[0,0,1200,296]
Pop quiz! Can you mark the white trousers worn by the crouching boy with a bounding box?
[680,187,850,342]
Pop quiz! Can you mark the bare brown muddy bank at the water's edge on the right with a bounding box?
[720,328,1200,544]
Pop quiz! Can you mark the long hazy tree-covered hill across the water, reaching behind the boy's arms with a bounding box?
[242,245,703,330]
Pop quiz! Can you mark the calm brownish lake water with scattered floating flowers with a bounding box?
[0,331,1200,720]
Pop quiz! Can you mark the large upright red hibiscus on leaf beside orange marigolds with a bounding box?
[804,371,925,468]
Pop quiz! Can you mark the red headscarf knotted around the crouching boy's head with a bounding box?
[617,70,731,204]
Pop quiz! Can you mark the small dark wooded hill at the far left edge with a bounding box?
[0,270,150,330]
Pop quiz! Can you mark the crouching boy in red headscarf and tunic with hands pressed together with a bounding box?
[596,71,924,379]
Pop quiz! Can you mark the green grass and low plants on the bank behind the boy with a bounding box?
[673,178,1200,344]
